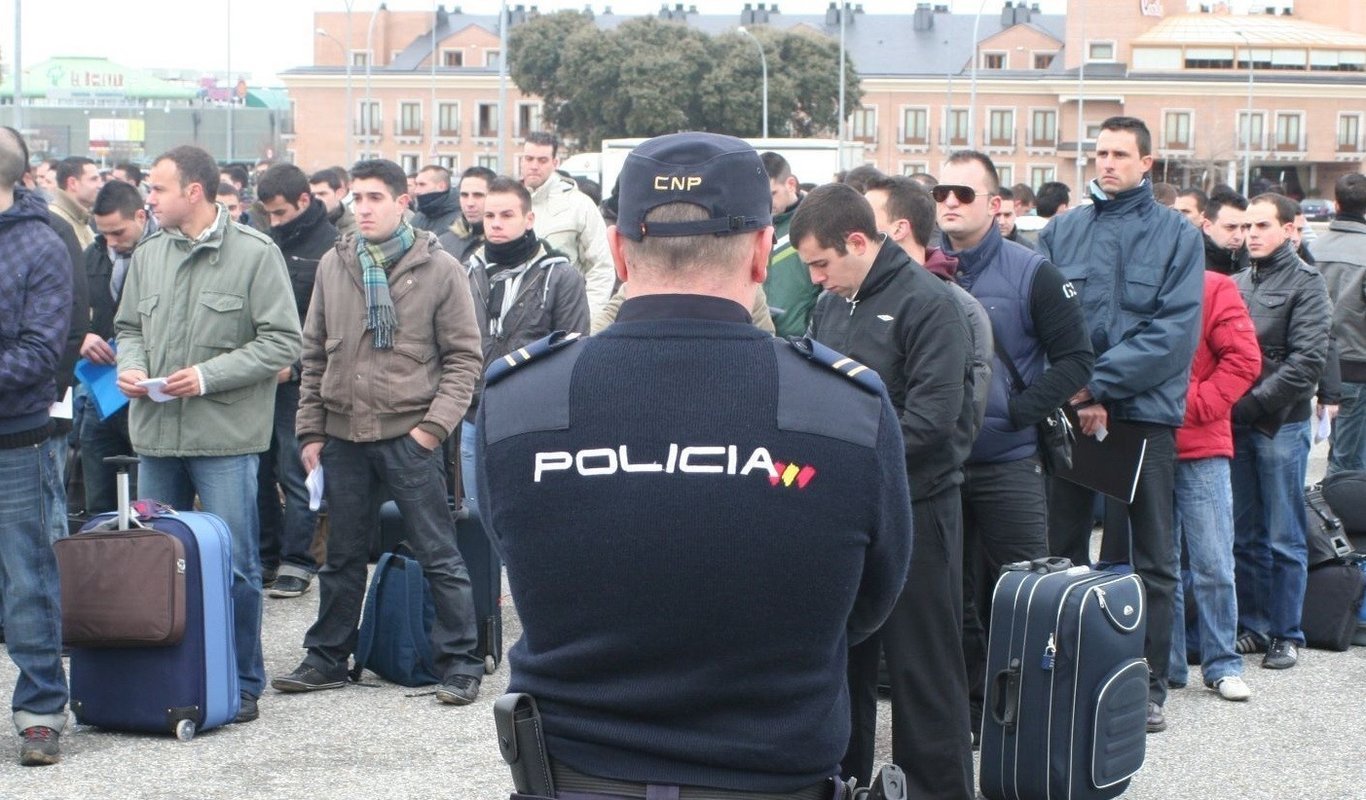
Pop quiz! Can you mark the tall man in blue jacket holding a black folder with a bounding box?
[1040,116,1205,732]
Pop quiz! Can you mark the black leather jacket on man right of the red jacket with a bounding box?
[1233,239,1332,435]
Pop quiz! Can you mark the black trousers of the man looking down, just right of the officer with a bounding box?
[840,486,973,800]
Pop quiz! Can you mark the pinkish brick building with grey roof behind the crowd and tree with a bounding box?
[283,0,1366,195]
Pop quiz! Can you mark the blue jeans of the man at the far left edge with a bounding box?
[0,438,67,730]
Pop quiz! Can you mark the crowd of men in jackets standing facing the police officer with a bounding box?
[0,117,1366,799]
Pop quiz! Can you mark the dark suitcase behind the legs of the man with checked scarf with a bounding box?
[377,500,503,674]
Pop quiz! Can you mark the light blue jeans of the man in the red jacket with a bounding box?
[1168,457,1243,684]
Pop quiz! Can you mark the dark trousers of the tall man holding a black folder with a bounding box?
[1048,423,1180,704]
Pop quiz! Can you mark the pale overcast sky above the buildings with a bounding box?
[0,0,1240,91]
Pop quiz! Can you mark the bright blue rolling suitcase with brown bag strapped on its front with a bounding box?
[71,455,242,740]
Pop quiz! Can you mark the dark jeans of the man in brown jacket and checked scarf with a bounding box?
[303,434,484,678]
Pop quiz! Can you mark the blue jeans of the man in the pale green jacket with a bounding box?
[138,453,265,698]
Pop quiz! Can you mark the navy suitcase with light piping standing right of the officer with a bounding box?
[981,558,1147,800]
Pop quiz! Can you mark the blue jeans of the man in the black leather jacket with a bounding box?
[1232,420,1310,644]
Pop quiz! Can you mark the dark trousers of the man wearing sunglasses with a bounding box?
[962,456,1048,730]
